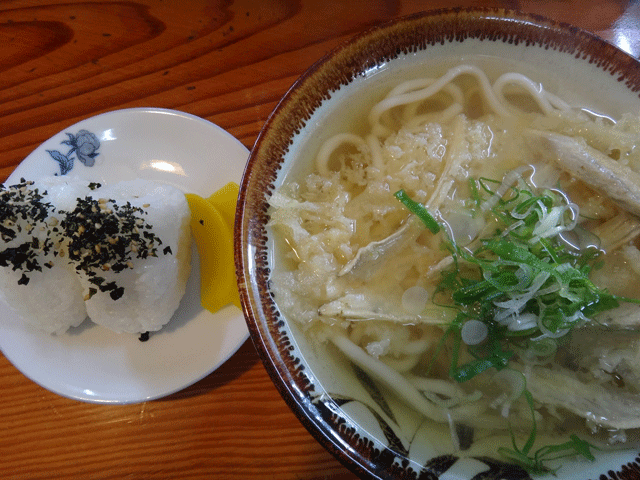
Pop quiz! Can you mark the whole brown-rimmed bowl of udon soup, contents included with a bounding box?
[235,10,640,479]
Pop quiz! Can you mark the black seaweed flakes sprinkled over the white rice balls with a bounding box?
[0,179,172,300]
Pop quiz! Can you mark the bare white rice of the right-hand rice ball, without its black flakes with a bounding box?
[76,179,191,333]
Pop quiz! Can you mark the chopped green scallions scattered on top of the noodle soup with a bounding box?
[395,172,640,473]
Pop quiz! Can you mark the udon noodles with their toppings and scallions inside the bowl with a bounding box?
[270,61,640,471]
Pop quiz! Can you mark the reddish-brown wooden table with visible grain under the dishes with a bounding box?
[0,0,640,480]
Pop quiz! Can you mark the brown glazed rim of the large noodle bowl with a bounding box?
[234,8,640,478]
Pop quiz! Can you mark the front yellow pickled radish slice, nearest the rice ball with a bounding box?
[186,189,240,313]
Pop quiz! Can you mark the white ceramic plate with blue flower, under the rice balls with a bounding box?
[0,108,249,403]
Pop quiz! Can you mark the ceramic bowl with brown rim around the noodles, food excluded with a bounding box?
[235,9,640,480]
